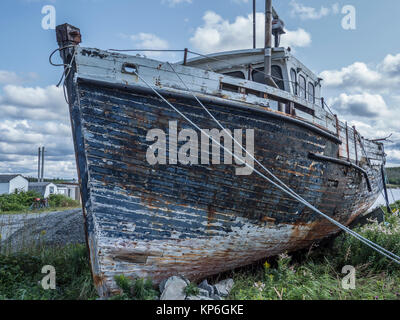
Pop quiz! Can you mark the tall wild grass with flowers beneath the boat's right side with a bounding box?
[229,202,400,300]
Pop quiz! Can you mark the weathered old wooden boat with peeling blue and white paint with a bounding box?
[57,6,385,296]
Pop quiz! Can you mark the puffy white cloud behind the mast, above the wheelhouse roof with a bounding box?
[190,11,311,53]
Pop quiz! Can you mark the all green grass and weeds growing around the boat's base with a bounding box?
[0,201,400,300]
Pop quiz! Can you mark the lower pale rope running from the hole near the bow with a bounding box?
[133,70,400,264]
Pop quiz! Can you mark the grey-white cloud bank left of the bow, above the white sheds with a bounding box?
[0,85,77,178]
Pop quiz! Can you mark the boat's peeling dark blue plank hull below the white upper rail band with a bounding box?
[68,79,382,296]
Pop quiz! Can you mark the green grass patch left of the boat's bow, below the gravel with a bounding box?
[0,245,97,300]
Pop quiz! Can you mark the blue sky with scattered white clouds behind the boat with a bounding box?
[0,0,400,178]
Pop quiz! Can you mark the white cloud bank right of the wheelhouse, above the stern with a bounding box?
[320,54,400,165]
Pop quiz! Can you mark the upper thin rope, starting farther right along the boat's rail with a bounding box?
[167,62,398,258]
